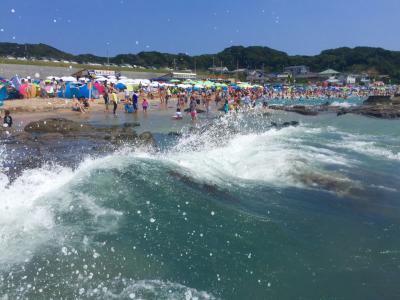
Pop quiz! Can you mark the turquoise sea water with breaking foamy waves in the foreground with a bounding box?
[0,111,400,299]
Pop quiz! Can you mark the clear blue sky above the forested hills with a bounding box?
[0,0,400,56]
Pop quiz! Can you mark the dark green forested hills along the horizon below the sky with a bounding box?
[0,43,400,80]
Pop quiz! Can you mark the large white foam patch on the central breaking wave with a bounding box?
[165,127,348,186]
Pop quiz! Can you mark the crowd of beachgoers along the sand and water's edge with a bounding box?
[4,77,398,126]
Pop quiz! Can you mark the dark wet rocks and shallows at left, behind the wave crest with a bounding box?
[0,118,157,180]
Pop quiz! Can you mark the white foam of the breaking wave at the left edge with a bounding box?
[0,158,124,269]
